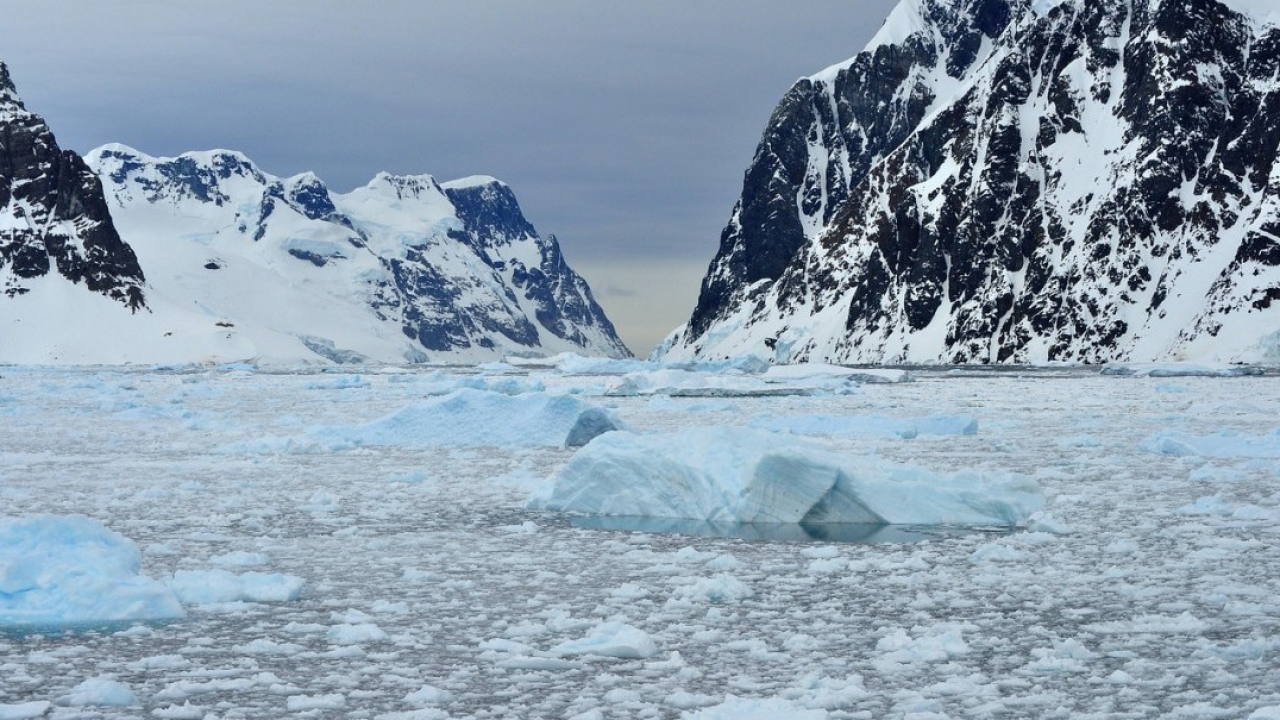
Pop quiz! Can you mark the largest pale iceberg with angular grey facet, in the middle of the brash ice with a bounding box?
[529,428,1044,527]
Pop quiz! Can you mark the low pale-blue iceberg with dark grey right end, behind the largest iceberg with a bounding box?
[311,389,622,447]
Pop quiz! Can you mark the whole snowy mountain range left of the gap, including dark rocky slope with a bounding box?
[0,64,630,363]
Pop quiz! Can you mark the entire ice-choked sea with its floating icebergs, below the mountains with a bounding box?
[0,355,1280,720]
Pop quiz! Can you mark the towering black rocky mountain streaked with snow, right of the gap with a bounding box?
[657,0,1280,363]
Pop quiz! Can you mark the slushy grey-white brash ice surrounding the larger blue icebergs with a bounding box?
[0,366,1280,719]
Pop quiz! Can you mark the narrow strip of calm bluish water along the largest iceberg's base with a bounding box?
[570,515,1010,544]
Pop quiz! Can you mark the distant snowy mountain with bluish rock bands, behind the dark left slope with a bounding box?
[80,145,627,361]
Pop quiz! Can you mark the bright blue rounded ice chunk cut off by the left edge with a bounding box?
[0,515,186,628]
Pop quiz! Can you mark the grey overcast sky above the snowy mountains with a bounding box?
[0,0,896,355]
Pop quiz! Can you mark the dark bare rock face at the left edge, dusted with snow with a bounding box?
[0,63,146,311]
